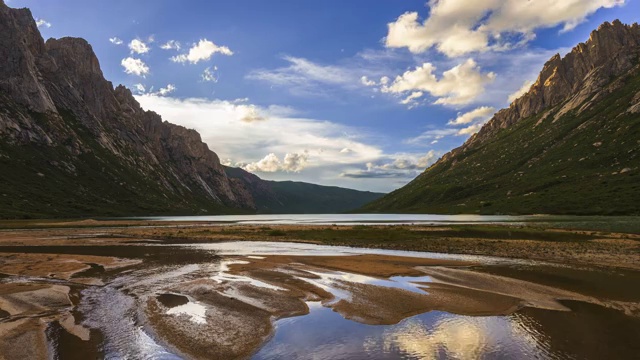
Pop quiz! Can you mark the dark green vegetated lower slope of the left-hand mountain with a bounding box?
[0,103,238,219]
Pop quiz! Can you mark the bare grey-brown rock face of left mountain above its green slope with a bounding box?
[0,3,255,212]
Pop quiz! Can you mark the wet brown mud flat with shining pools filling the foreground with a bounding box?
[0,233,640,359]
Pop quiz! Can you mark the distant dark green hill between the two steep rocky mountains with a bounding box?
[226,167,384,214]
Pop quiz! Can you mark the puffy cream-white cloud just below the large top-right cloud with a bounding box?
[381,59,496,105]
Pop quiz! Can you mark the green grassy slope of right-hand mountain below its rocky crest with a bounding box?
[363,25,640,215]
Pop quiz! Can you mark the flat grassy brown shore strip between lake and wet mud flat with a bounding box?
[0,220,640,270]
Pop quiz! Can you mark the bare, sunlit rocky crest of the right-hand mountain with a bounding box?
[465,20,640,147]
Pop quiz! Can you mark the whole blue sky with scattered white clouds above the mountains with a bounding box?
[6,0,640,192]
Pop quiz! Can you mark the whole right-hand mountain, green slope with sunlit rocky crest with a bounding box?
[363,20,640,214]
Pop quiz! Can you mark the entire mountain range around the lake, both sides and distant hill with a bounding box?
[0,0,640,218]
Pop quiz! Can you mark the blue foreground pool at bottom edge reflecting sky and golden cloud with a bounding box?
[253,303,553,360]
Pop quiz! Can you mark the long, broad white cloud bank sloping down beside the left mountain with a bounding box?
[136,94,382,166]
